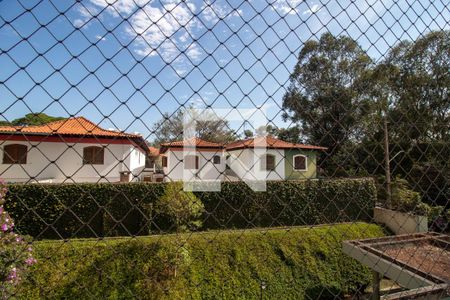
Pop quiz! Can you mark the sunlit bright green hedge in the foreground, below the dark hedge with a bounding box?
[17,223,383,299]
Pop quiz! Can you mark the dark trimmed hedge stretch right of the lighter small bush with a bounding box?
[196,178,376,229]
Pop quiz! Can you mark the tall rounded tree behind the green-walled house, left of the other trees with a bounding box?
[283,33,372,154]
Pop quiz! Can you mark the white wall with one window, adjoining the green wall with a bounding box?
[229,149,285,180]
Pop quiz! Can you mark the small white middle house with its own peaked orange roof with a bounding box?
[159,138,225,181]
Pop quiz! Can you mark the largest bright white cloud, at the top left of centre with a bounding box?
[81,0,203,74]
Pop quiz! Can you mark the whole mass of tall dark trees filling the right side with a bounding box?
[283,31,450,206]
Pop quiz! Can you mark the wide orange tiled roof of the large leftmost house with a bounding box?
[0,117,141,138]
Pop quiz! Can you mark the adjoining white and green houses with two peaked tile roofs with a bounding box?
[159,136,326,181]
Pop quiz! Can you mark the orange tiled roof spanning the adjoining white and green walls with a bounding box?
[225,136,327,150]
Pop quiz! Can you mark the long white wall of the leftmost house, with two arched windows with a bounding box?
[0,141,145,182]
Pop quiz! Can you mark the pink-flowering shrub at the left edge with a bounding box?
[0,183,36,299]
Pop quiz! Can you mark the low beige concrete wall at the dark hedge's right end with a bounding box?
[374,207,428,234]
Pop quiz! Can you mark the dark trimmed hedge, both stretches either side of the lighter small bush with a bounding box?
[6,178,376,238]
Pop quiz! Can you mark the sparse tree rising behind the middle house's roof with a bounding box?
[153,109,238,145]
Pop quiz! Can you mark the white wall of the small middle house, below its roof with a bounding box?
[163,149,225,181]
